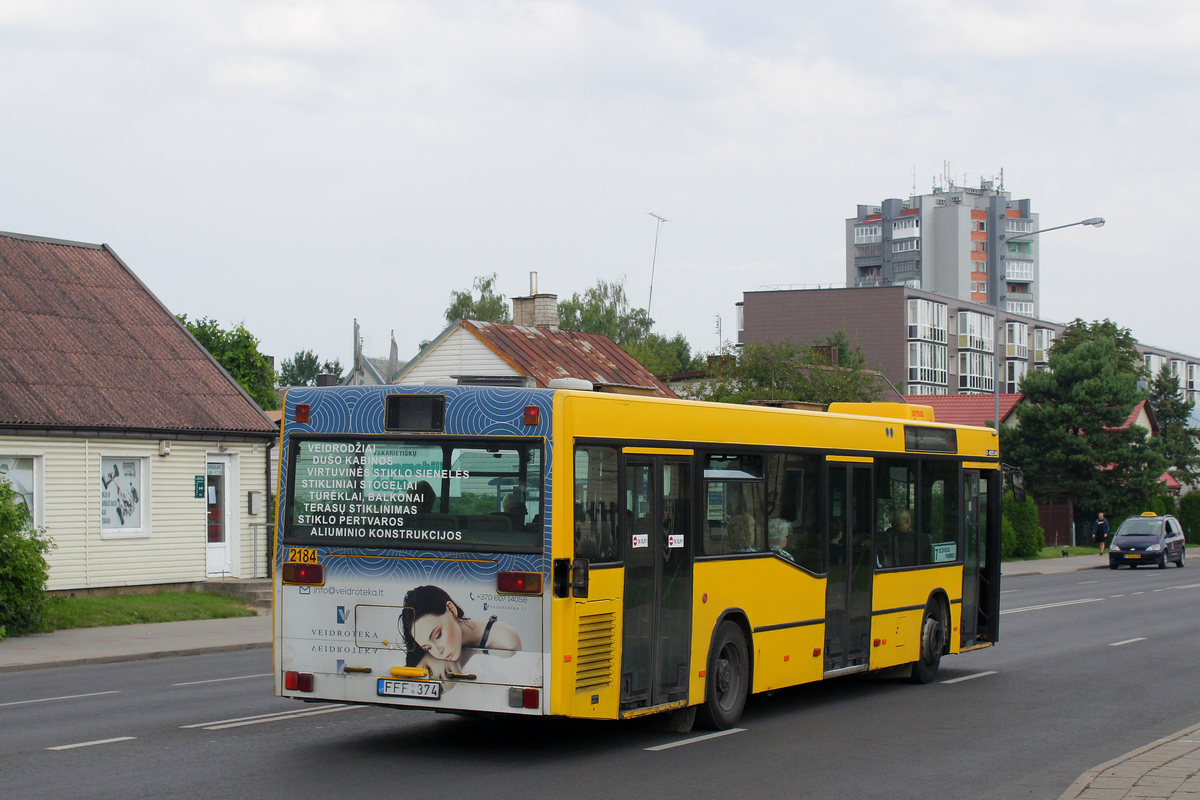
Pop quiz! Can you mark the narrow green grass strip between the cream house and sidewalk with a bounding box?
[41,591,256,631]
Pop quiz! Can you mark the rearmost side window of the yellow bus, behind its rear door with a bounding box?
[575,446,618,564]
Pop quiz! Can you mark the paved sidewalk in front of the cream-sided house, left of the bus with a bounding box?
[0,613,271,673]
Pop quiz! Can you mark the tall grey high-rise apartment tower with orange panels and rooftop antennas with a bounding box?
[846,180,1039,318]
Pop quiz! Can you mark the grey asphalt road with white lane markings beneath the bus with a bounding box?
[0,567,1200,800]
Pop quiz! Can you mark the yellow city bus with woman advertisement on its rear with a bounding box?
[275,385,1002,729]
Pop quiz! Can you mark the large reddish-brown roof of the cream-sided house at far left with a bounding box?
[0,233,275,433]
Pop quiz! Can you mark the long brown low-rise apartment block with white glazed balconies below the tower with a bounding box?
[739,284,1200,401]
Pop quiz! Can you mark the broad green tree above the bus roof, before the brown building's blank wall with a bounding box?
[685,332,883,404]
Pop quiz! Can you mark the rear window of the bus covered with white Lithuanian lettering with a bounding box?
[284,439,542,552]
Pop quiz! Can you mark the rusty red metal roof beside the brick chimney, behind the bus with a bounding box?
[462,319,677,397]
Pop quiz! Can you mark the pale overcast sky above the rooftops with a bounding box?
[0,0,1200,366]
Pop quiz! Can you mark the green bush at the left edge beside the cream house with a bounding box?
[0,481,54,638]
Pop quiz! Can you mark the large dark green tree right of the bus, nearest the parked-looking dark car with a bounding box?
[1001,332,1165,521]
